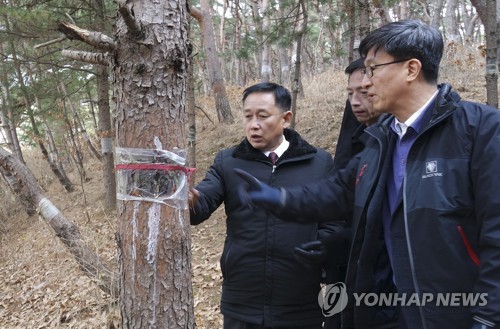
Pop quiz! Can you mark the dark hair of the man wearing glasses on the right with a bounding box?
[359,20,444,83]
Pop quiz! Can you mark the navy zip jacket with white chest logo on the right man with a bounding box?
[281,85,500,329]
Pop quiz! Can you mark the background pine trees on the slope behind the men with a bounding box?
[0,0,498,163]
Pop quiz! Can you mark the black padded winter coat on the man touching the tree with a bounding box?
[190,129,333,328]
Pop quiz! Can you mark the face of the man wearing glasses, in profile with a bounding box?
[362,50,408,114]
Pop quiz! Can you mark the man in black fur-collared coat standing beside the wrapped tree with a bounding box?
[189,83,333,329]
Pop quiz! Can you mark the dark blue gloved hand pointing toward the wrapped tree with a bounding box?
[234,168,284,210]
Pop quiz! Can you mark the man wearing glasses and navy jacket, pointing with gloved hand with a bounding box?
[239,20,500,329]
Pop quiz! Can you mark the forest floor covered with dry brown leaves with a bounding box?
[0,47,486,329]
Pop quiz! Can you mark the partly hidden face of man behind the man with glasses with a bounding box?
[347,69,378,126]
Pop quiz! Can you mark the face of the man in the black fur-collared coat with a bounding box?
[243,92,292,152]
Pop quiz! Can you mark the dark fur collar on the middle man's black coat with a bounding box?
[233,129,317,161]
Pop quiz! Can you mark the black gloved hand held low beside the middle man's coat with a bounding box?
[294,228,352,266]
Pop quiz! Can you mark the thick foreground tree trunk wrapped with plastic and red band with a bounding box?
[112,0,195,329]
